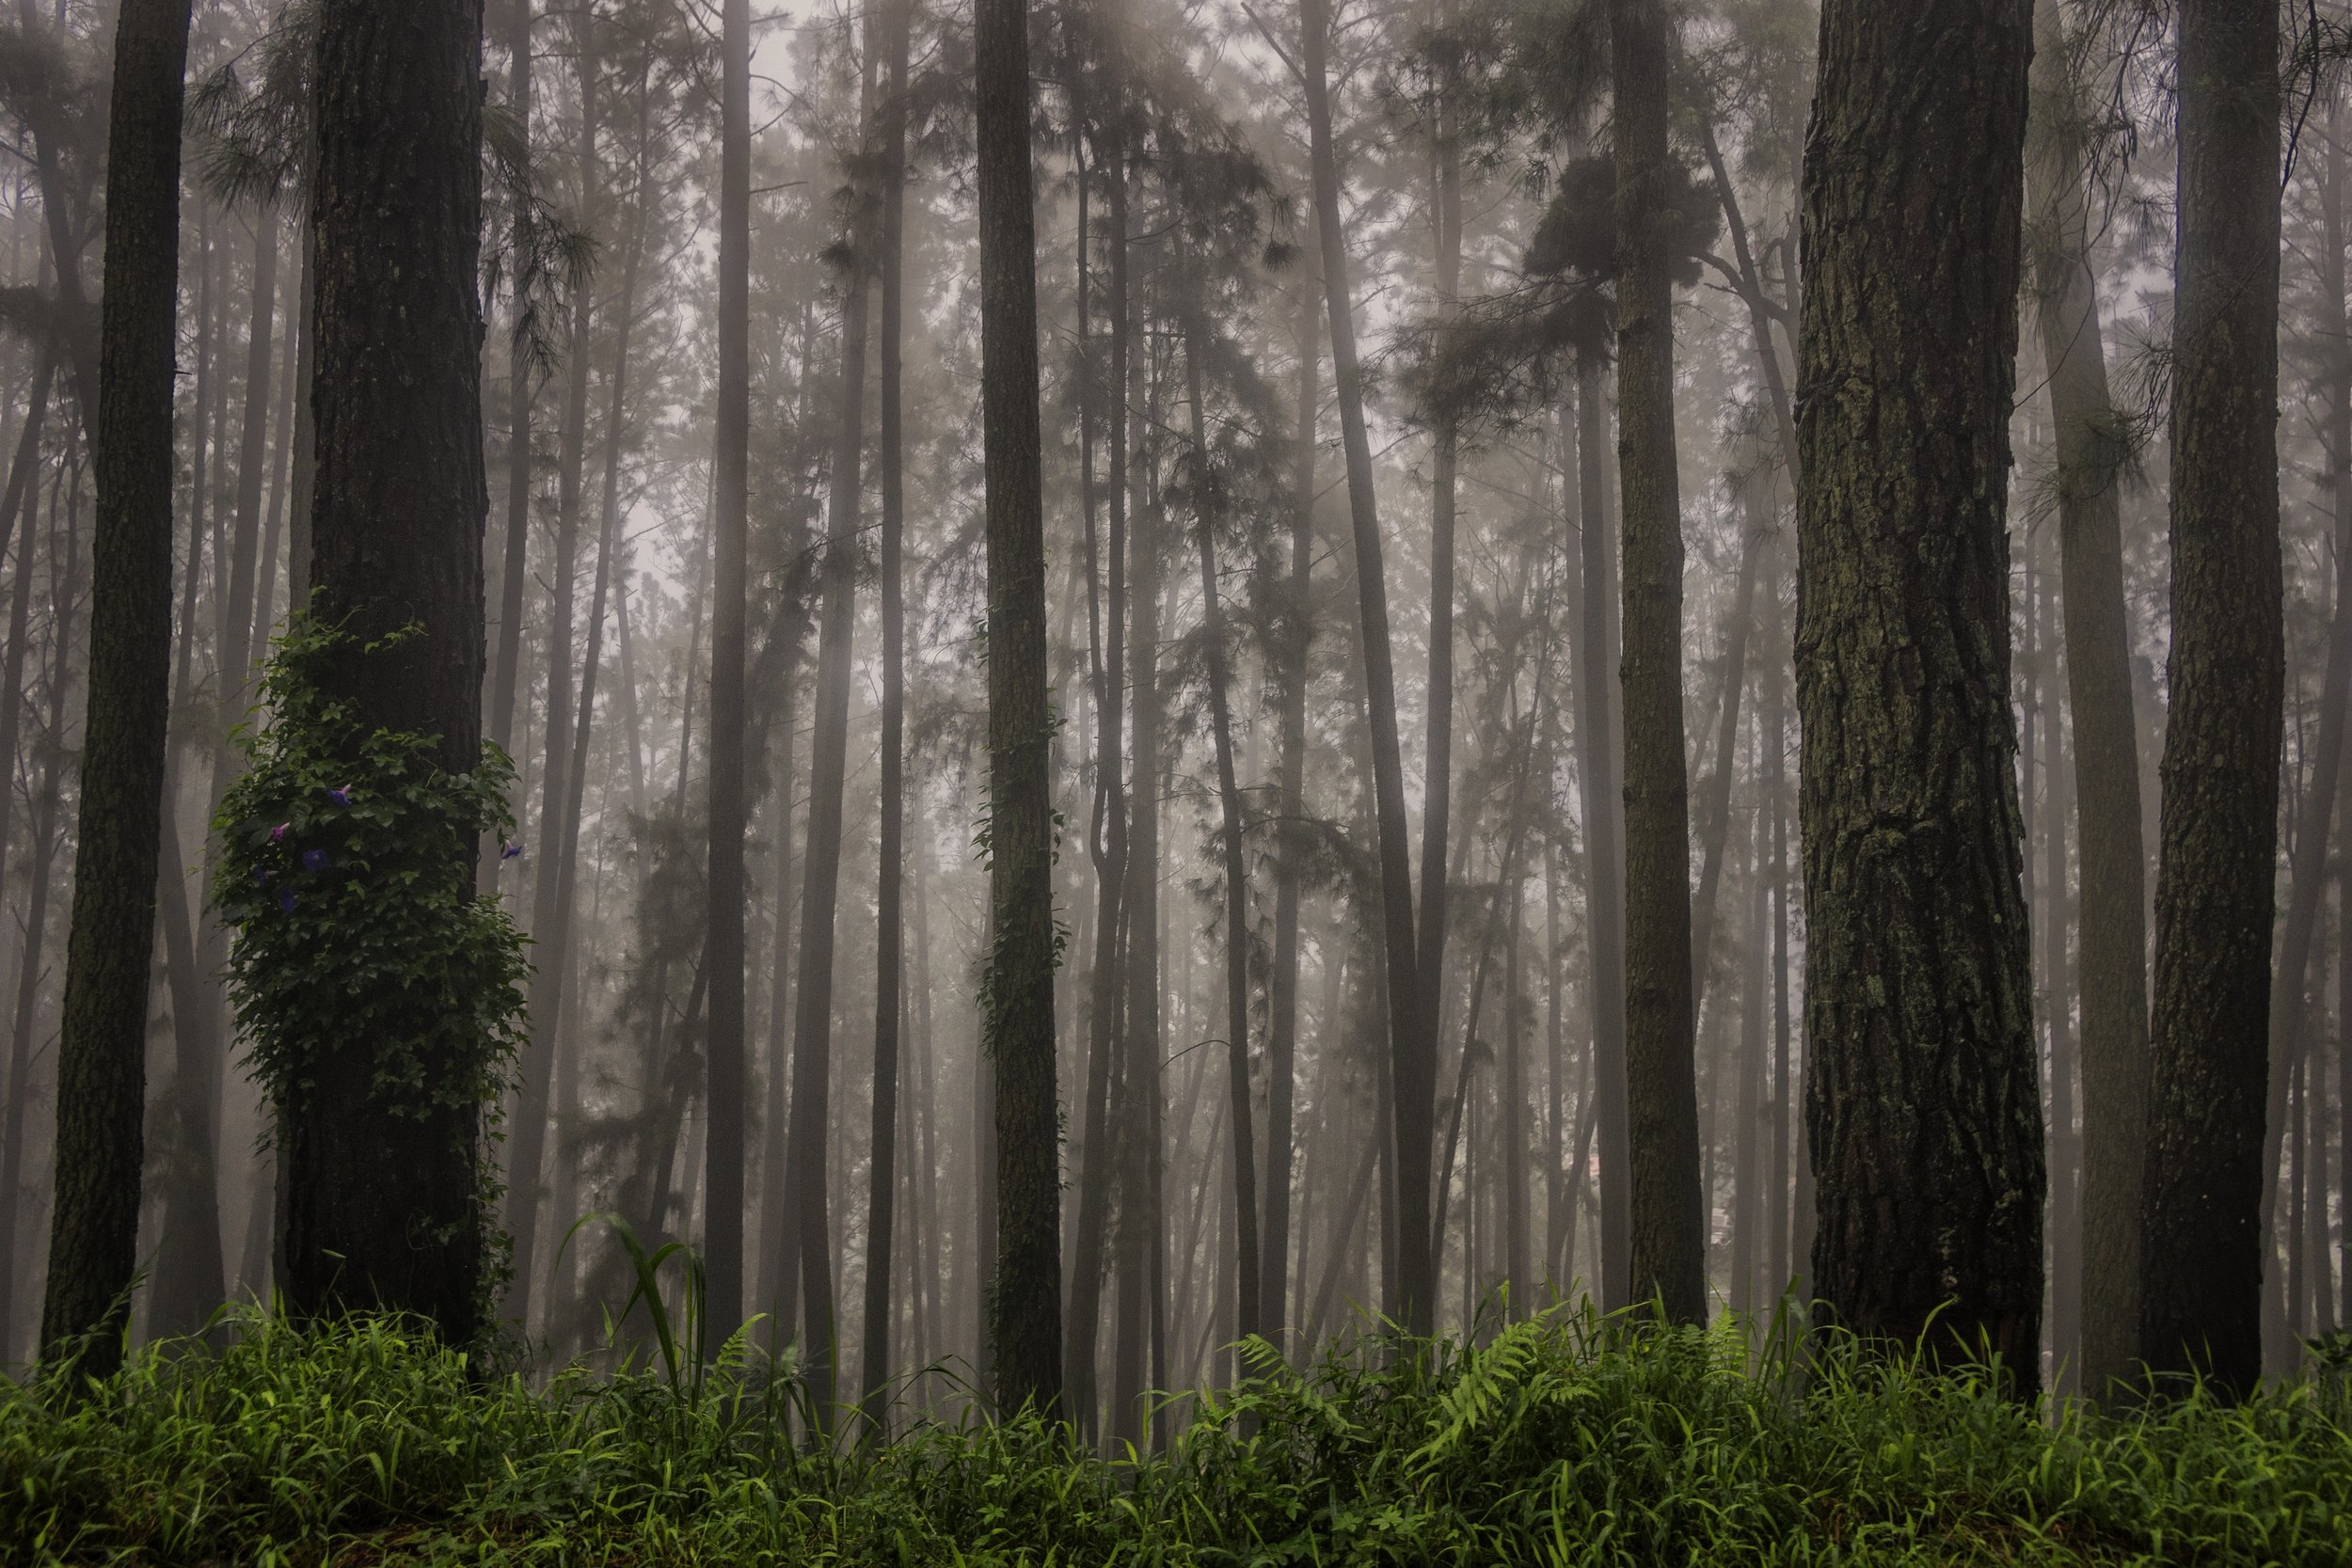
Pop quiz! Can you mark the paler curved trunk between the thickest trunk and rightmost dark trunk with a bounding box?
[2026,0,2154,1397]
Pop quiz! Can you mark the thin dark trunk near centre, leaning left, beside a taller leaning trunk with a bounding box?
[1185,315,1263,1340]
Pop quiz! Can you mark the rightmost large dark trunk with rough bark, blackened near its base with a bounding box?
[2140,0,2286,1392]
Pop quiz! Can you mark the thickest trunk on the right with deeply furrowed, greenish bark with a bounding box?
[1797,0,2044,1394]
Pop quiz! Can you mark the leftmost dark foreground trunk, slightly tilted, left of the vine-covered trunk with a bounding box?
[40,0,188,1375]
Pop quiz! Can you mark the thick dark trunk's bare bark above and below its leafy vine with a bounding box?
[280,0,489,1342]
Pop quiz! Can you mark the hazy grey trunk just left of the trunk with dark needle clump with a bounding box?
[1569,345,1632,1312]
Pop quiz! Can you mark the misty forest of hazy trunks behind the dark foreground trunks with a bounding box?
[0,0,2324,1439]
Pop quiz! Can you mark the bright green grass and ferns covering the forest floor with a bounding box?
[0,1312,2352,1566]
